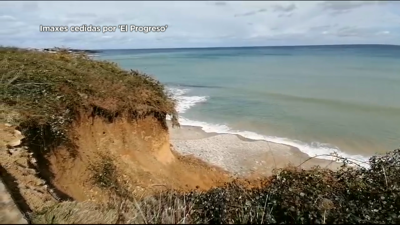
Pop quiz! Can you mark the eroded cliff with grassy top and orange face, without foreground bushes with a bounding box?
[0,48,228,220]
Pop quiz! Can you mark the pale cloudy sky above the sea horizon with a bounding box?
[0,1,400,49]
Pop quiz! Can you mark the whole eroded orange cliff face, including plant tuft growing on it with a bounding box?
[5,116,229,206]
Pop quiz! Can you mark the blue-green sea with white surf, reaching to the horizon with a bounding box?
[95,45,400,161]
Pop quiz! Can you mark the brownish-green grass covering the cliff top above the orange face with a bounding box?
[0,47,179,147]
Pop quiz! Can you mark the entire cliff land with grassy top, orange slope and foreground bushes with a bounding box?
[0,48,400,224]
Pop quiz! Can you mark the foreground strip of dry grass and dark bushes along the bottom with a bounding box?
[32,149,400,224]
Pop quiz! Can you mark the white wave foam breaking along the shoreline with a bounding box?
[167,88,369,167]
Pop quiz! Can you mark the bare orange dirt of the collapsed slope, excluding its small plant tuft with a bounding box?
[43,114,230,201]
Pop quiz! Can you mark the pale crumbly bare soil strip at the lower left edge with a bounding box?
[0,123,57,223]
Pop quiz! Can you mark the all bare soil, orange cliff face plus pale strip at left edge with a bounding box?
[0,117,231,217]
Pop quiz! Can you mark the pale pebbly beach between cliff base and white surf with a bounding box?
[169,124,340,176]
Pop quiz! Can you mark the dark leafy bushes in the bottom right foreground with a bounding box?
[178,149,400,224]
